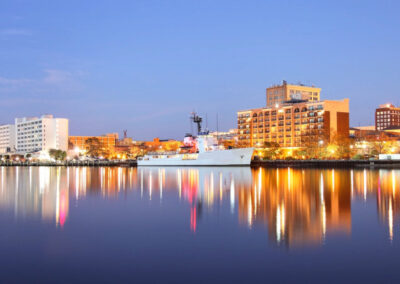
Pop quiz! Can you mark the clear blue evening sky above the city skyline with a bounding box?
[0,0,400,140]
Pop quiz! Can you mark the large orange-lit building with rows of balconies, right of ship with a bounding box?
[237,99,349,147]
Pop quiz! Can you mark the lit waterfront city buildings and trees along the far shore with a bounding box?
[0,81,400,163]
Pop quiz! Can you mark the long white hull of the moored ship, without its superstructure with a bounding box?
[138,148,254,166]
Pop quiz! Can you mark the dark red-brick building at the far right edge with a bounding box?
[375,104,400,130]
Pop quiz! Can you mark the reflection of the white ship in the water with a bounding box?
[138,167,251,232]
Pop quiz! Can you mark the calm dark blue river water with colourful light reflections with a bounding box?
[0,167,400,283]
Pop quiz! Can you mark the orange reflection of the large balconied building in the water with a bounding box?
[238,169,351,246]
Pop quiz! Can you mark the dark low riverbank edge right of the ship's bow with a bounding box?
[251,160,400,169]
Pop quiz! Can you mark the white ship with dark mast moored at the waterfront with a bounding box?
[138,114,254,166]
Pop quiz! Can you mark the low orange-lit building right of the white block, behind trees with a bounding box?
[68,133,118,152]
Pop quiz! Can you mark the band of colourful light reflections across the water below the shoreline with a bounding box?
[0,167,400,246]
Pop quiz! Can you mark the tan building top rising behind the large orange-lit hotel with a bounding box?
[266,81,321,107]
